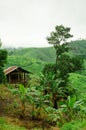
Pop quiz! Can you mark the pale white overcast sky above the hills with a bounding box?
[0,0,86,47]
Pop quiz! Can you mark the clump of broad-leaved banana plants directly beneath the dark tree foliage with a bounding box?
[41,73,65,109]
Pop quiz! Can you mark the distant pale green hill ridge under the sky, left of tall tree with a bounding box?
[9,47,55,62]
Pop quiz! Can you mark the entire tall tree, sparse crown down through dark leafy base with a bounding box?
[43,25,83,109]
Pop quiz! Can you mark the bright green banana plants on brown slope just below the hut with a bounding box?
[11,84,49,119]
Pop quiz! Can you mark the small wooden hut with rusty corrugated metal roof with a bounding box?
[4,66,30,84]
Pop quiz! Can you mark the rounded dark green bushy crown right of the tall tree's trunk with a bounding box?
[57,54,84,78]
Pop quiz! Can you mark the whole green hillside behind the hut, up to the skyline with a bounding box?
[6,47,55,74]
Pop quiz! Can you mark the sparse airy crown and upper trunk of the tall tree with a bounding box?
[47,25,73,64]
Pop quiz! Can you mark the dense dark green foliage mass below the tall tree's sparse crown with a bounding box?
[43,54,82,108]
